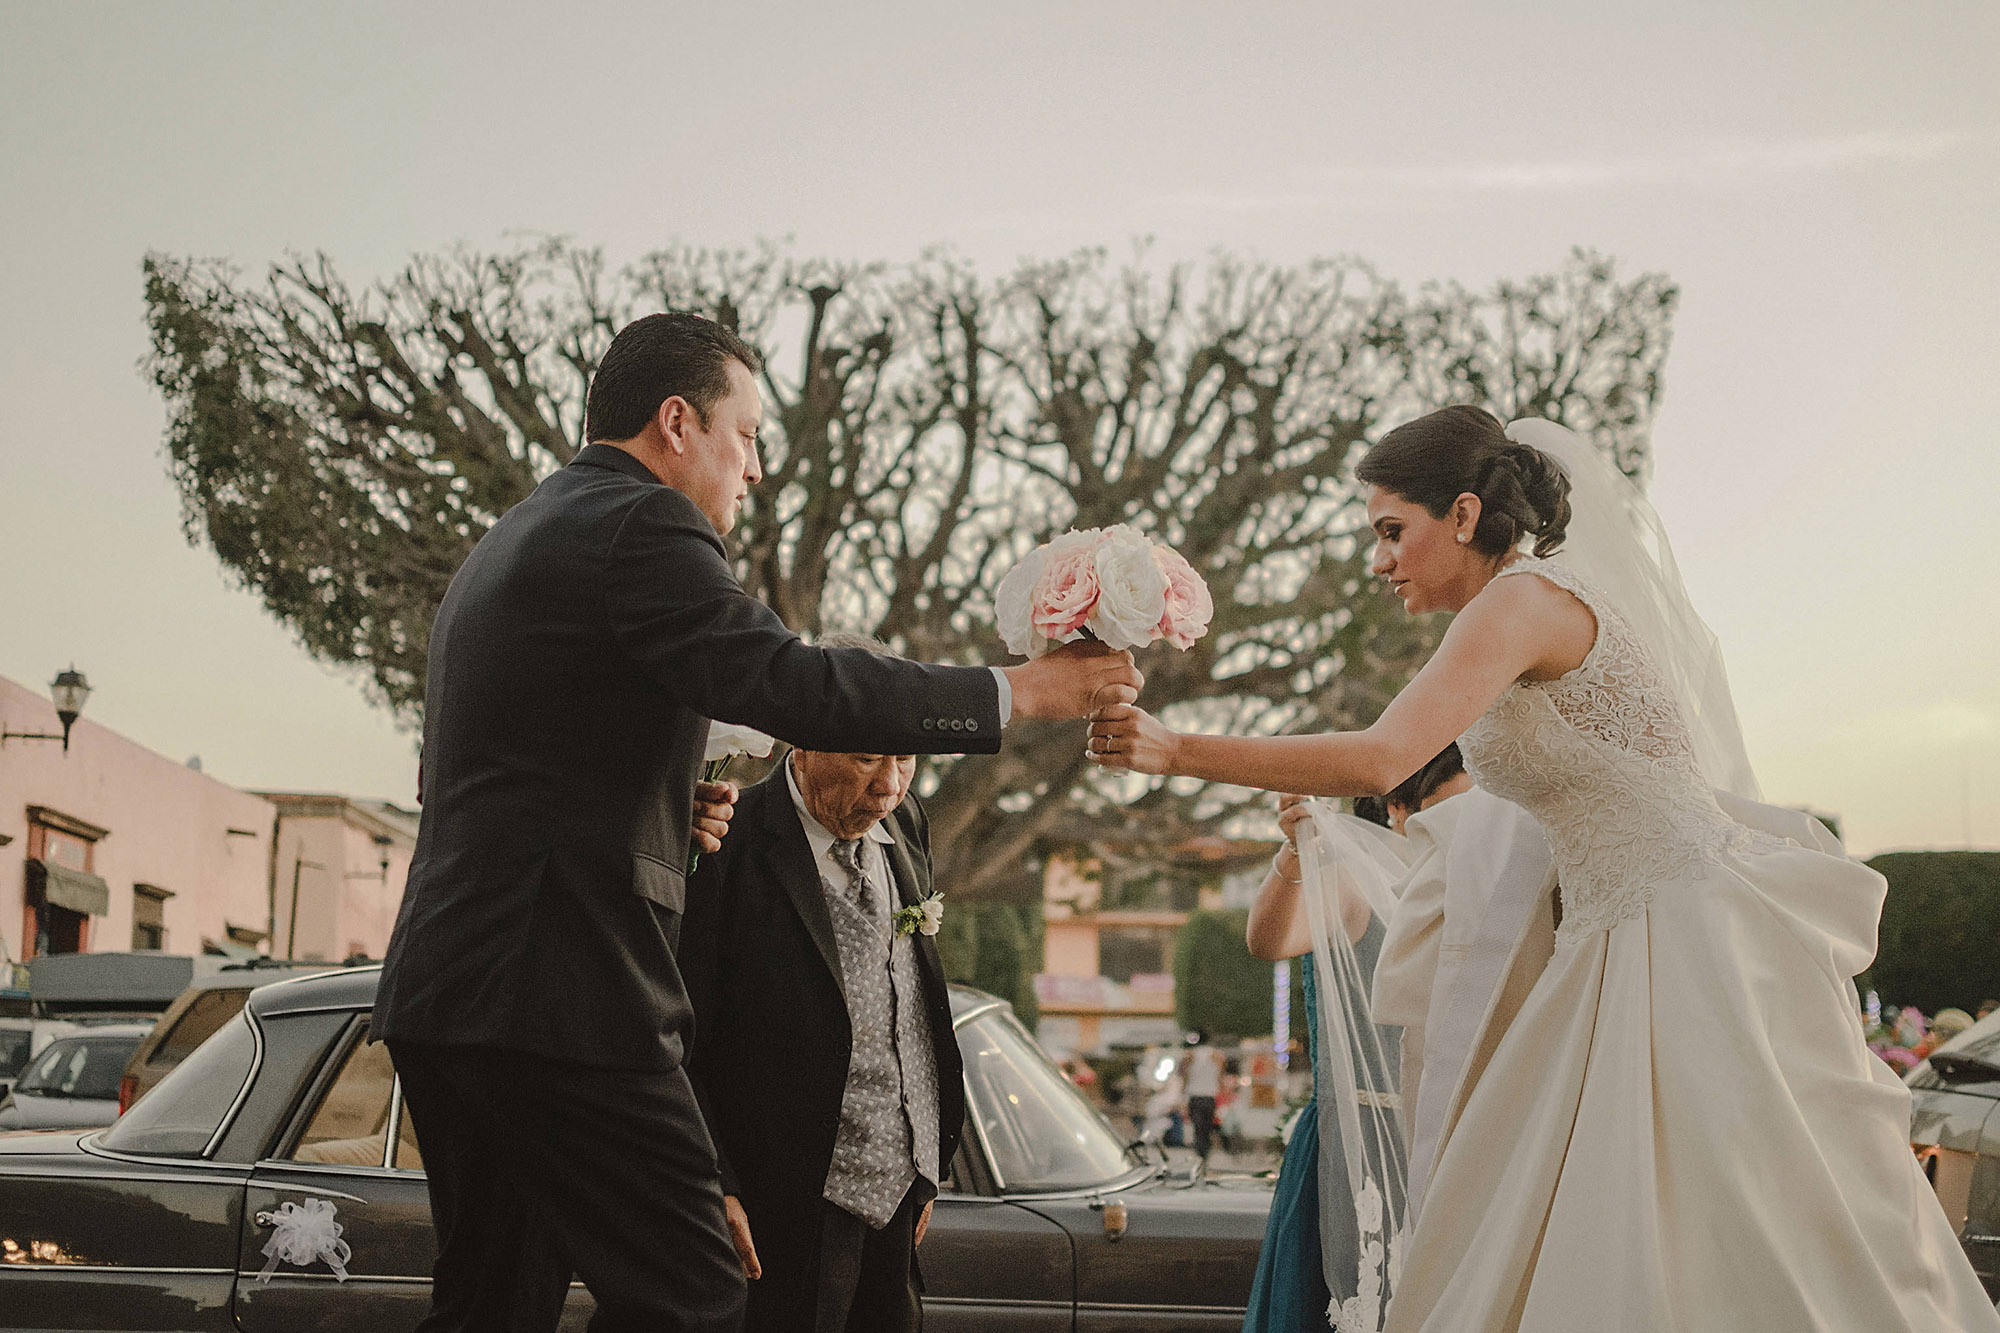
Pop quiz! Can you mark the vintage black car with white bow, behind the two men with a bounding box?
[0,969,1270,1333]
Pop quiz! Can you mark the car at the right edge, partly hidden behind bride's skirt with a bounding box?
[1904,1000,2000,1303]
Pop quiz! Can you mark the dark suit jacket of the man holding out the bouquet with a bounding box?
[372,444,1000,1069]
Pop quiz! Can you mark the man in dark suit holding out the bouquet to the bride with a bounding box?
[372,314,1138,1333]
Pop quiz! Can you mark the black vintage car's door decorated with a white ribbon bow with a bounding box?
[236,1015,592,1333]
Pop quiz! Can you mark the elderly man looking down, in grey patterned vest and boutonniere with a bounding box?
[680,636,966,1333]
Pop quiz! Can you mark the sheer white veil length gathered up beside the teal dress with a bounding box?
[1298,801,1408,1333]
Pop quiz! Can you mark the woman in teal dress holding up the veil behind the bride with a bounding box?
[1244,745,1470,1333]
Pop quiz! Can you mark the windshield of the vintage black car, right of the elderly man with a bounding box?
[958,1009,1132,1193]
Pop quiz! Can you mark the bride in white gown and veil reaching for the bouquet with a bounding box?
[1090,406,2000,1333]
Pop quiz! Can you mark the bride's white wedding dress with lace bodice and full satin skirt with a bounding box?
[1388,558,2000,1333]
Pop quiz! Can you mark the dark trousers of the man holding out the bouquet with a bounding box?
[388,1041,744,1333]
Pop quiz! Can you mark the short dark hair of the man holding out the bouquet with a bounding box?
[584,314,764,440]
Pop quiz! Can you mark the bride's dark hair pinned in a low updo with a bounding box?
[1354,406,1570,556]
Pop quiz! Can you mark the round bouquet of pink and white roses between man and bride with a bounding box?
[994,522,1216,656]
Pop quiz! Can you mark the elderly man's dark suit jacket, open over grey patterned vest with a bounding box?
[680,769,966,1329]
